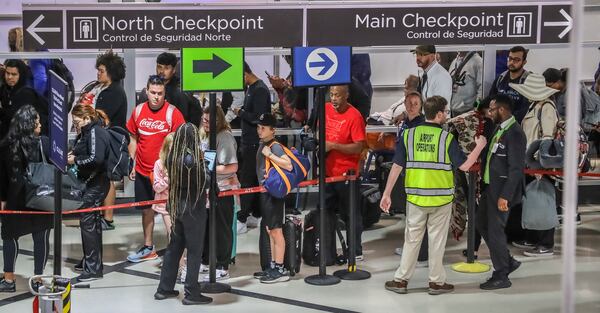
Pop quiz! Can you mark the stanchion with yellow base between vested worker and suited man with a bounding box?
[452,168,490,273]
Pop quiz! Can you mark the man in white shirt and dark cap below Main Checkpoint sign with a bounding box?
[410,45,452,103]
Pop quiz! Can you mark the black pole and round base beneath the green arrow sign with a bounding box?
[200,92,231,294]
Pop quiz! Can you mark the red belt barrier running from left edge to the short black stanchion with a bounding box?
[0,175,357,215]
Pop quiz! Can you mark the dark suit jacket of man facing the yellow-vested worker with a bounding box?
[486,123,527,206]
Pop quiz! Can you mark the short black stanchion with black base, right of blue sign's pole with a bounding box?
[333,170,371,280]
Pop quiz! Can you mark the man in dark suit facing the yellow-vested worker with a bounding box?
[477,95,527,290]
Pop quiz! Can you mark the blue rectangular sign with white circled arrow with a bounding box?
[292,47,352,87]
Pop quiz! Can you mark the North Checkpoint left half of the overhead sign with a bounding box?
[23,4,303,49]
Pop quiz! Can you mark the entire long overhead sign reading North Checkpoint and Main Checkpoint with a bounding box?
[23,0,572,49]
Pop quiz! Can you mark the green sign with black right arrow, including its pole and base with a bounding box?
[181,48,244,293]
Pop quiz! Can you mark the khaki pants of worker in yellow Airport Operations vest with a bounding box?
[394,202,452,284]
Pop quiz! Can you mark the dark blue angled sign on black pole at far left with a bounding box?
[50,71,68,275]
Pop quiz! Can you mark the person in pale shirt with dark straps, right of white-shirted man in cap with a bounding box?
[450,51,483,117]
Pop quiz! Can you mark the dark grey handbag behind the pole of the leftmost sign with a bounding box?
[25,141,85,212]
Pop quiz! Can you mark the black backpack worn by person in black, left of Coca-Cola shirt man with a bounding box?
[105,126,133,181]
